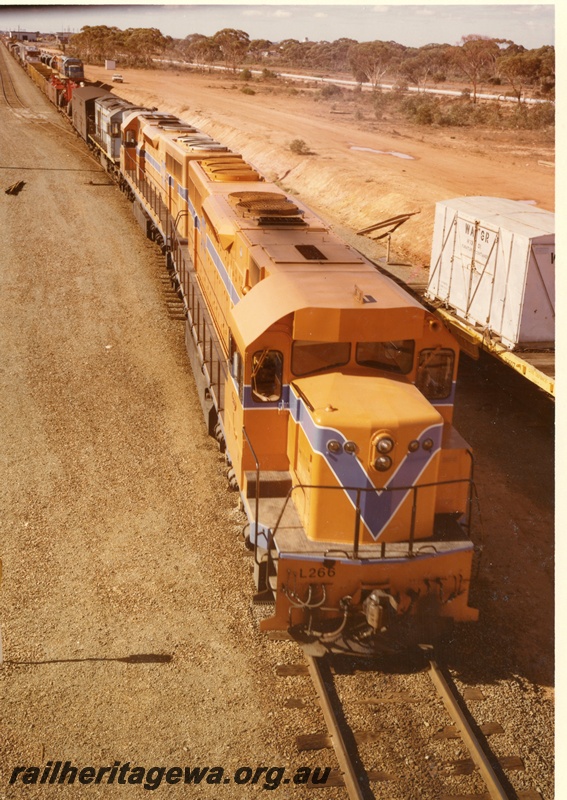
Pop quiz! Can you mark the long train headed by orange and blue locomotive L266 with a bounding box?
[8,40,478,653]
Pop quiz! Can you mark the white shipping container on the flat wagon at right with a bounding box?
[426,197,555,350]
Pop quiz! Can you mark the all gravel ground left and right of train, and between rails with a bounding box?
[0,48,553,800]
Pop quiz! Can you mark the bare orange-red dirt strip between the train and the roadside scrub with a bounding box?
[86,67,555,266]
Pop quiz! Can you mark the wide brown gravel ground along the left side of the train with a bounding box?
[0,46,332,800]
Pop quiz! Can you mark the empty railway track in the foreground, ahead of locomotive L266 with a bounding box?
[276,652,542,800]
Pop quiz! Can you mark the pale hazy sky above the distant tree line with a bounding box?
[0,0,555,49]
